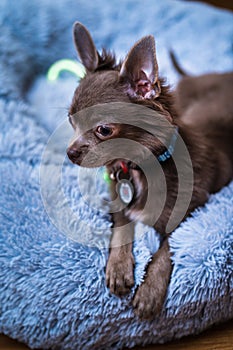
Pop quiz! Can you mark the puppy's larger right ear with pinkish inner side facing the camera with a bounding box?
[120,35,161,99]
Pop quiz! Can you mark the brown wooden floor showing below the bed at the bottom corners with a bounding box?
[0,320,233,350]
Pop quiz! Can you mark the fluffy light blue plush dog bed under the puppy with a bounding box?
[0,0,233,350]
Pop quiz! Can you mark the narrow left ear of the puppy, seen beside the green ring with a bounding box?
[73,22,98,72]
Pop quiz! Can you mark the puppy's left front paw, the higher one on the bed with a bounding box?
[106,253,134,296]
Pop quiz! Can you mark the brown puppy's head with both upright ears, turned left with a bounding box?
[67,23,172,167]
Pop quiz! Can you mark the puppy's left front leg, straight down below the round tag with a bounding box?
[106,212,134,296]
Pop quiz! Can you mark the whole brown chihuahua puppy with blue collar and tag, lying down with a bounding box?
[67,22,233,319]
